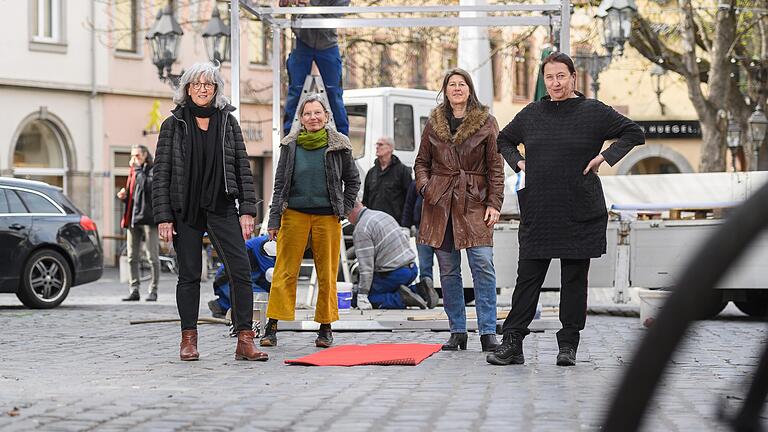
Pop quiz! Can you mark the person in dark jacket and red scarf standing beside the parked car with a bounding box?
[117,145,160,301]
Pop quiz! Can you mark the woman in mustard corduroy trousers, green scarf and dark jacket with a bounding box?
[261,95,360,348]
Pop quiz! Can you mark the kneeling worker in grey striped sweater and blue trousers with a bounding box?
[348,202,437,309]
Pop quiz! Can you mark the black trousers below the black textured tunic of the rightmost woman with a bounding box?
[502,258,589,349]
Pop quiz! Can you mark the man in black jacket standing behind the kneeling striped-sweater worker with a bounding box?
[363,137,413,222]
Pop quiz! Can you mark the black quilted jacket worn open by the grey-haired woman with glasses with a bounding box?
[152,105,256,224]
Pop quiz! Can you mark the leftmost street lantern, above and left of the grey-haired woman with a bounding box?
[146,4,184,87]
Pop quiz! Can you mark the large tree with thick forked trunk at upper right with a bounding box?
[629,0,768,172]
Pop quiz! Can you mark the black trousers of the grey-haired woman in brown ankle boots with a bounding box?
[173,206,253,331]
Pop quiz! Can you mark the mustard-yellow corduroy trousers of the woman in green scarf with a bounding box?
[267,209,341,324]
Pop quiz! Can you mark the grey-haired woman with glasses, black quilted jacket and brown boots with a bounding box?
[152,63,268,361]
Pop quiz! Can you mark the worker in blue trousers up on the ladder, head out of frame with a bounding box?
[279,0,349,136]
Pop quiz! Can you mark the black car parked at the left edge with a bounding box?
[0,177,104,309]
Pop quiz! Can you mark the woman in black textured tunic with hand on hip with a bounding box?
[487,53,645,366]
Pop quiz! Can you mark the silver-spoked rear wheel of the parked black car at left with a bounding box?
[16,249,72,309]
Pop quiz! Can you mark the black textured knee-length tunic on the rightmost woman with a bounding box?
[497,94,645,259]
